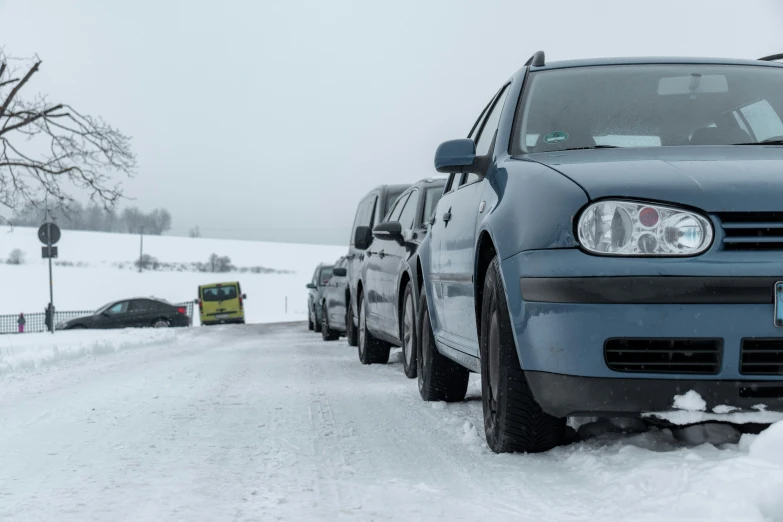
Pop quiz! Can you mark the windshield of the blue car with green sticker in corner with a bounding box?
[511,65,783,154]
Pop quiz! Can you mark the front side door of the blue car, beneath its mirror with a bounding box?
[436,86,507,356]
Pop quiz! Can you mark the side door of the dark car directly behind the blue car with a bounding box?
[379,188,419,338]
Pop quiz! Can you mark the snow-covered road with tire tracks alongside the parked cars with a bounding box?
[0,324,783,521]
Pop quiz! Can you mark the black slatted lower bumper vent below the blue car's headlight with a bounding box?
[604,339,723,374]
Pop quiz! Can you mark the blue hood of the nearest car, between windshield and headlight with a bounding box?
[519,146,783,212]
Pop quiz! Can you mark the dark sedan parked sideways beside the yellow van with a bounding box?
[57,297,191,330]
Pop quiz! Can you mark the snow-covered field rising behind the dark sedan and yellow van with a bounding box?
[0,227,347,323]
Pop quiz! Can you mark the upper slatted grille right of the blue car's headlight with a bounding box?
[718,212,783,250]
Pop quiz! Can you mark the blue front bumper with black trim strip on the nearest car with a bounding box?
[501,250,783,416]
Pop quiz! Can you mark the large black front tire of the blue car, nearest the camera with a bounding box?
[479,257,566,453]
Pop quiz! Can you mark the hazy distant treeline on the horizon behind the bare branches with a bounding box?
[10,203,171,236]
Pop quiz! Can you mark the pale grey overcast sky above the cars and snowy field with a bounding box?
[0,0,783,244]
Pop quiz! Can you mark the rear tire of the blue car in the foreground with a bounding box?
[417,289,470,402]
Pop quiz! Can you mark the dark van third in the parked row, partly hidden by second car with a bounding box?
[346,185,410,346]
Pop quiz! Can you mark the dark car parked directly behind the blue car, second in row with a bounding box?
[355,179,446,372]
